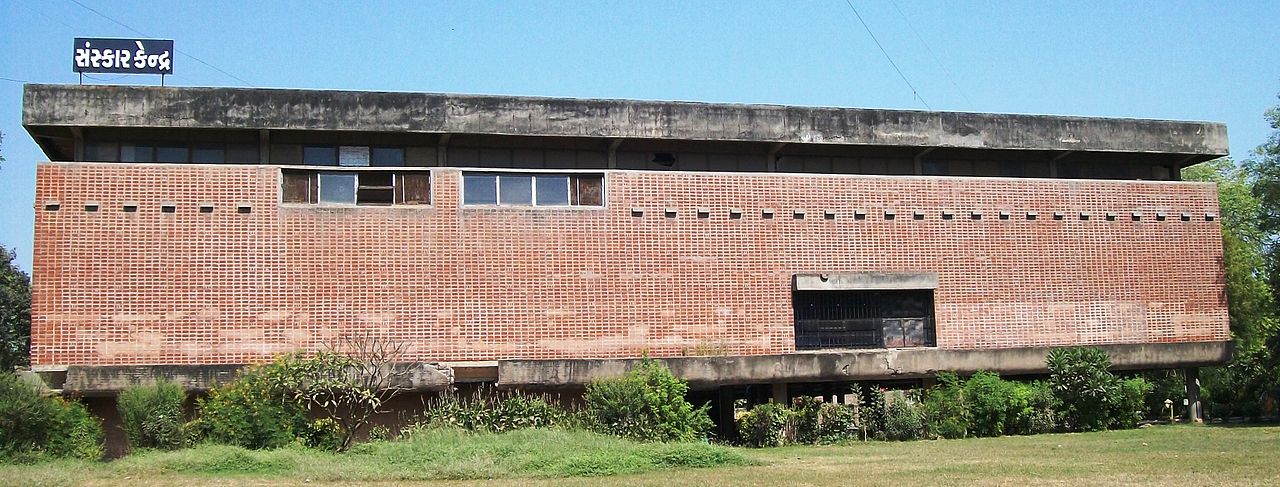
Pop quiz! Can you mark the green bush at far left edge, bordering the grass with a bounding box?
[0,372,102,460]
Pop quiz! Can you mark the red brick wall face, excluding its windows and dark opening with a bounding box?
[32,164,1229,365]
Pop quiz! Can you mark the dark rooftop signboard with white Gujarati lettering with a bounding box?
[72,37,173,74]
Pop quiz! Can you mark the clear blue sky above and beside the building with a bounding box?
[0,0,1280,269]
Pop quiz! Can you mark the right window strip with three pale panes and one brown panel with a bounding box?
[462,173,604,206]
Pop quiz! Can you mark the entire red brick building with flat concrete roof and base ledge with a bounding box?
[23,85,1230,415]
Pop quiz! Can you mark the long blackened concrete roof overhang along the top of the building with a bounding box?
[23,85,1228,160]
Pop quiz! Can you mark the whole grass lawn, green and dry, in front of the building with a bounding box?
[10,425,1280,487]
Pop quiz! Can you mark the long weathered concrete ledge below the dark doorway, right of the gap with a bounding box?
[498,342,1231,388]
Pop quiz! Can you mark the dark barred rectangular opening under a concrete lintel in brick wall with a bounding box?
[791,290,936,350]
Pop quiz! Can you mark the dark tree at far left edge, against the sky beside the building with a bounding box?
[0,246,31,370]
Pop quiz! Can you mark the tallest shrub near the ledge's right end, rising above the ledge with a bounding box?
[1046,347,1120,431]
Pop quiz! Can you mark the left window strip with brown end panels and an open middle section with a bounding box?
[280,169,431,206]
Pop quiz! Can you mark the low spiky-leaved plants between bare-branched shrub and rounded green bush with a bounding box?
[417,388,572,433]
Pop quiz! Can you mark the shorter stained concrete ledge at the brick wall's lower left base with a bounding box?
[56,363,453,396]
